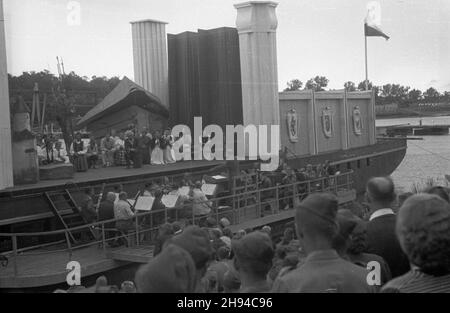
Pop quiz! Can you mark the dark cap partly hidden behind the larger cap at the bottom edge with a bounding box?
[168,226,213,269]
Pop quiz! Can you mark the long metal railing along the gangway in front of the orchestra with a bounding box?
[0,171,353,276]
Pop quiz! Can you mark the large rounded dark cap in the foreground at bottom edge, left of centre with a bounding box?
[135,244,196,293]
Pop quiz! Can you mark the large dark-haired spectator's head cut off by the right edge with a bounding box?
[396,194,450,276]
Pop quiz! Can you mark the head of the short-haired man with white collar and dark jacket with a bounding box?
[366,177,397,212]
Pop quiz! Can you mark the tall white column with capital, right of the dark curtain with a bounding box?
[234,1,280,125]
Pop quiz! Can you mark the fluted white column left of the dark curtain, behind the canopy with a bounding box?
[131,20,169,107]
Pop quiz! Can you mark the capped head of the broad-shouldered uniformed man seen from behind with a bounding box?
[295,193,338,254]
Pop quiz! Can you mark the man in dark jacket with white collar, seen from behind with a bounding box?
[366,177,410,278]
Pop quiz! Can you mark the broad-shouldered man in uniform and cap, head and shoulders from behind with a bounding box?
[272,193,378,293]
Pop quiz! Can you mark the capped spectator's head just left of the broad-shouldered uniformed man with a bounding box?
[232,231,274,281]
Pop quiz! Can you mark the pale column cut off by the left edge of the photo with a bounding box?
[0,0,14,190]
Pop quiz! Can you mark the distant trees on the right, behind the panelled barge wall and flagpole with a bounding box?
[284,76,450,106]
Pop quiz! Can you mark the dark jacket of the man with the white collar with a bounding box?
[367,214,410,278]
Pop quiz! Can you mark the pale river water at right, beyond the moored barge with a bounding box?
[376,116,450,192]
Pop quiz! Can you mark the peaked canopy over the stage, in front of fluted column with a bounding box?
[77,77,169,137]
